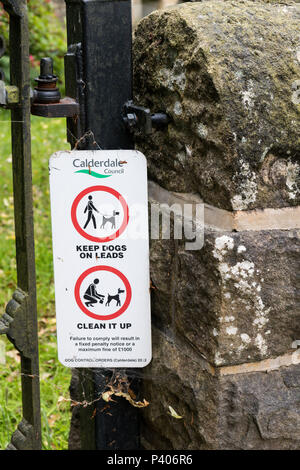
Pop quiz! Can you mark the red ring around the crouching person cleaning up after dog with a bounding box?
[74,266,132,320]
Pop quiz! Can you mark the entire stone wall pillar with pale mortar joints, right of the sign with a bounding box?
[134,0,300,449]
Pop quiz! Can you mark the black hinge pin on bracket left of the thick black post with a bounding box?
[31,57,79,118]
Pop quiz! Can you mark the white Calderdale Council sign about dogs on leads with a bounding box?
[49,150,151,368]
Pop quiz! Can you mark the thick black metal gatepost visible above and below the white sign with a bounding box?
[66,0,139,450]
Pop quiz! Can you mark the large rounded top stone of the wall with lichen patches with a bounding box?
[134,0,300,210]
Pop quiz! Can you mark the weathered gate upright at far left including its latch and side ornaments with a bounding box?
[0,0,41,450]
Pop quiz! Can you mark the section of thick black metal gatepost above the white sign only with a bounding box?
[66,0,134,150]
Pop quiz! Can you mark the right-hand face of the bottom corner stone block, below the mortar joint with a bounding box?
[217,365,300,450]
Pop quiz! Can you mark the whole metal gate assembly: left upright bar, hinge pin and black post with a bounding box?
[0,0,142,449]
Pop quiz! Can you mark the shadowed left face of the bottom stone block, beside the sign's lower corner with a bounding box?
[142,328,217,450]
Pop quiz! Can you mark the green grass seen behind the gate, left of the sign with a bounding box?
[0,110,70,450]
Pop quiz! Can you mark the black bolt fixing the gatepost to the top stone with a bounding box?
[122,100,170,135]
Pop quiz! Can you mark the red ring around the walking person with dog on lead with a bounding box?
[71,186,129,243]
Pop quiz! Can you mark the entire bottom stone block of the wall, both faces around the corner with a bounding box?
[141,329,300,450]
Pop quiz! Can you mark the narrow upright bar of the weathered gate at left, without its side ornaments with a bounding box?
[3,0,41,449]
